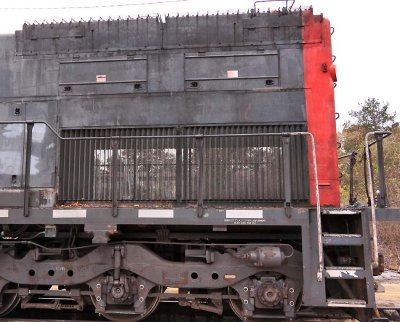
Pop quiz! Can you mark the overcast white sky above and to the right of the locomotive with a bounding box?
[0,0,400,126]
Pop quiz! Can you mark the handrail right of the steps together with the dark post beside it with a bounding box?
[365,131,392,268]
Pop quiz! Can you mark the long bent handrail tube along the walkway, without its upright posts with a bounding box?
[0,120,324,281]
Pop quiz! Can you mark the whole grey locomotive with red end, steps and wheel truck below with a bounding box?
[0,3,394,322]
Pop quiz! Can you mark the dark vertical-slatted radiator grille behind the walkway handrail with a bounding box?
[59,125,309,201]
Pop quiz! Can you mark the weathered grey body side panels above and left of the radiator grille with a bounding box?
[0,13,308,201]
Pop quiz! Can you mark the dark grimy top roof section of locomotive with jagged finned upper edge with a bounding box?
[15,7,322,56]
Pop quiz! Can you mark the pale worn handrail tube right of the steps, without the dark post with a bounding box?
[365,131,392,268]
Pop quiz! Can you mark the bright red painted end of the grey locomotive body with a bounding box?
[303,10,340,207]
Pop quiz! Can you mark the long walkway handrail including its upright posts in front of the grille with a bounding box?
[0,120,324,280]
